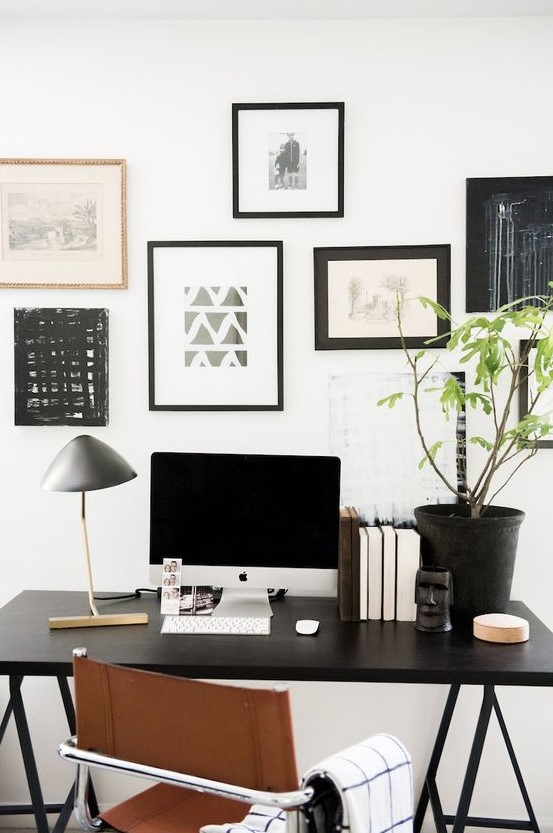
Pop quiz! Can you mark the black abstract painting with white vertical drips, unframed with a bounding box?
[466,176,553,312]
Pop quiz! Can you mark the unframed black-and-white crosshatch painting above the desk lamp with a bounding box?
[14,307,108,425]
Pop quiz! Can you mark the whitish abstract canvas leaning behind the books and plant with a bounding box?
[329,372,465,525]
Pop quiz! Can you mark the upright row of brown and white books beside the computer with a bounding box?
[338,506,420,622]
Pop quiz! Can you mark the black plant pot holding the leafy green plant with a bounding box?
[415,503,524,623]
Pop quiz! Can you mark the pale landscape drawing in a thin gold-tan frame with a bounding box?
[0,159,127,289]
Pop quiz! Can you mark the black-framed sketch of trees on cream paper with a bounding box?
[313,244,451,350]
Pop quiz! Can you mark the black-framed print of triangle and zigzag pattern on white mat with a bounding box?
[148,241,283,411]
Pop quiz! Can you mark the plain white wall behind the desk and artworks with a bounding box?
[0,18,553,830]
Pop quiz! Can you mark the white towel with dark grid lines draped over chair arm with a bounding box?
[303,734,413,833]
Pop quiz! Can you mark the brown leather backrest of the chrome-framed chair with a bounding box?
[74,657,298,792]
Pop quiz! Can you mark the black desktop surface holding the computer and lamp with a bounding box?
[0,590,553,686]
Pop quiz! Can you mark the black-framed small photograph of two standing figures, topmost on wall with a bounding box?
[232,102,344,218]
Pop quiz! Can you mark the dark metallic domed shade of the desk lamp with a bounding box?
[41,434,136,492]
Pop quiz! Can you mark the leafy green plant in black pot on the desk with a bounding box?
[378,284,553,621]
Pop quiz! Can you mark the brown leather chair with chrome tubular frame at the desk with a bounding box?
[58,648,314,833]
